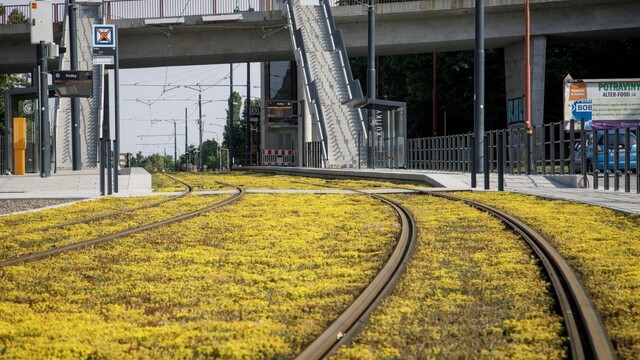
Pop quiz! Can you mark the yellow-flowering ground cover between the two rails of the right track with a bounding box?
[335,195,567,359]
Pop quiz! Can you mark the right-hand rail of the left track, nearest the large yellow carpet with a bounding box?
[0,180,245,268]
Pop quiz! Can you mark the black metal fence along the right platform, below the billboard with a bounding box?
[407,121,640,193]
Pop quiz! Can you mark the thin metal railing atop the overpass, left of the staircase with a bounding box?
[0,0,272,25]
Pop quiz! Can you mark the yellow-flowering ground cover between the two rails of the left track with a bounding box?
[0,195,227,260]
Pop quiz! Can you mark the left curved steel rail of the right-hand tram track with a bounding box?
[296,194,417,360]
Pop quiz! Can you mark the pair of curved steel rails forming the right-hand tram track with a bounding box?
[258,174,616,359]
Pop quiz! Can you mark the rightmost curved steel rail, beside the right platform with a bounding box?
[423,192,616,359]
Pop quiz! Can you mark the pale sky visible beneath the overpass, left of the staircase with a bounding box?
[110,63,260,155]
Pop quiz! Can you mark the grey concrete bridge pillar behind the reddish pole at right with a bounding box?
[504,36,548,127]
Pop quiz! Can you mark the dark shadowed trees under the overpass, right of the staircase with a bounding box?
[351,39,640,138]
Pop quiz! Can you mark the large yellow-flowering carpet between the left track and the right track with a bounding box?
[0,194,399,359]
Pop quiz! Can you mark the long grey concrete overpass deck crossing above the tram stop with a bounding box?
[0,0,640,73]
